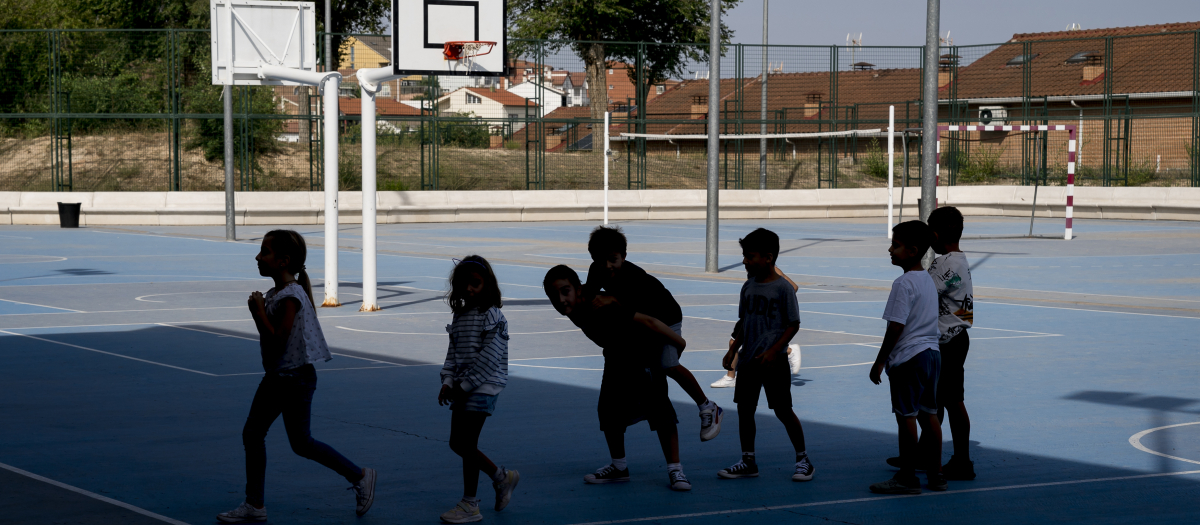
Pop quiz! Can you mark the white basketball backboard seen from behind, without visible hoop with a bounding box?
[209,0,317,85]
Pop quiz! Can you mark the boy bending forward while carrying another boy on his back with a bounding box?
[542,265,691,490]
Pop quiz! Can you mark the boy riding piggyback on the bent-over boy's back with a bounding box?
[584,227,724,441]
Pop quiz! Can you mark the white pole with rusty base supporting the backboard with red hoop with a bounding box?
[354,67,401,312]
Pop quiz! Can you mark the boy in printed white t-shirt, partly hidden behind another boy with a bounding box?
[929,206,976,479]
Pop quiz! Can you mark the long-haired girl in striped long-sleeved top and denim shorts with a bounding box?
[438,255,521,523]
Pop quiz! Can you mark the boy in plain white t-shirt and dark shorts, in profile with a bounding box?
[870,221,947,494]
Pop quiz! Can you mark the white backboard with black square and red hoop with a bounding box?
[391,0,509,77]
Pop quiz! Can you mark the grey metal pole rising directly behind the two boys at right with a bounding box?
[920,0,941,221]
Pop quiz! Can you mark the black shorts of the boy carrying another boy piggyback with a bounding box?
[596,360,679,432]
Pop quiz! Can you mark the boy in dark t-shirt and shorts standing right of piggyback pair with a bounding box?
[716,228,816,481]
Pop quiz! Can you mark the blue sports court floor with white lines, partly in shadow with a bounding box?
[0,217,1200,525]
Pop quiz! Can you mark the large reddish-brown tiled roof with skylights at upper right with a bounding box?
[940,22,1200,98]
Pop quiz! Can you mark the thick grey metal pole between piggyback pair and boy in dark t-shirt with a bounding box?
[704,0,720,273]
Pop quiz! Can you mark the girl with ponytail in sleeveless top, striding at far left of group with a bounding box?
[217,230,376,523]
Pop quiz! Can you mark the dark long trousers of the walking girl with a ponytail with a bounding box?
[241,364,362,507]
